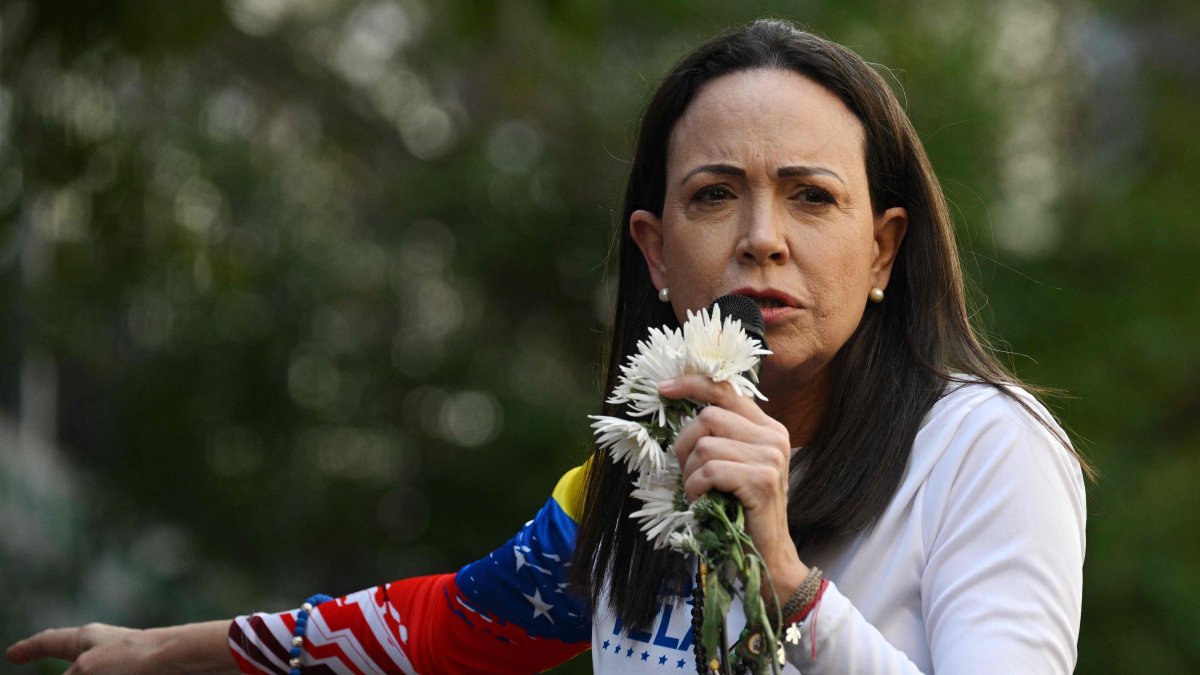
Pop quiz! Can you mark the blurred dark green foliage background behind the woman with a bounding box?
[0,0,1200,673]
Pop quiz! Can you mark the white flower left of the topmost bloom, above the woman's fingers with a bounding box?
[608,328,684,426]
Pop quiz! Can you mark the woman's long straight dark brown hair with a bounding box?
[572,19,1087,626]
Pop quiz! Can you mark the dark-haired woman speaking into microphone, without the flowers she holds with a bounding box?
[8,20,1085,674]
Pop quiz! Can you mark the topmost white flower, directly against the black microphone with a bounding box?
[683,306,770,400]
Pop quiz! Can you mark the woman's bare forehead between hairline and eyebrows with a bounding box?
[667,68,865,180]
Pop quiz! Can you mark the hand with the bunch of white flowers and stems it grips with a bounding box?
[593,305,798,671]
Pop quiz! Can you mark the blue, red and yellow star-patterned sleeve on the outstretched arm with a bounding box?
[229,467,592,675]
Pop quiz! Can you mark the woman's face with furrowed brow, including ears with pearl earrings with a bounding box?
[630,70,907,384]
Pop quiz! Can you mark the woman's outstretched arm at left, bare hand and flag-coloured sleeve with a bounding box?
[7,461,590,675]
